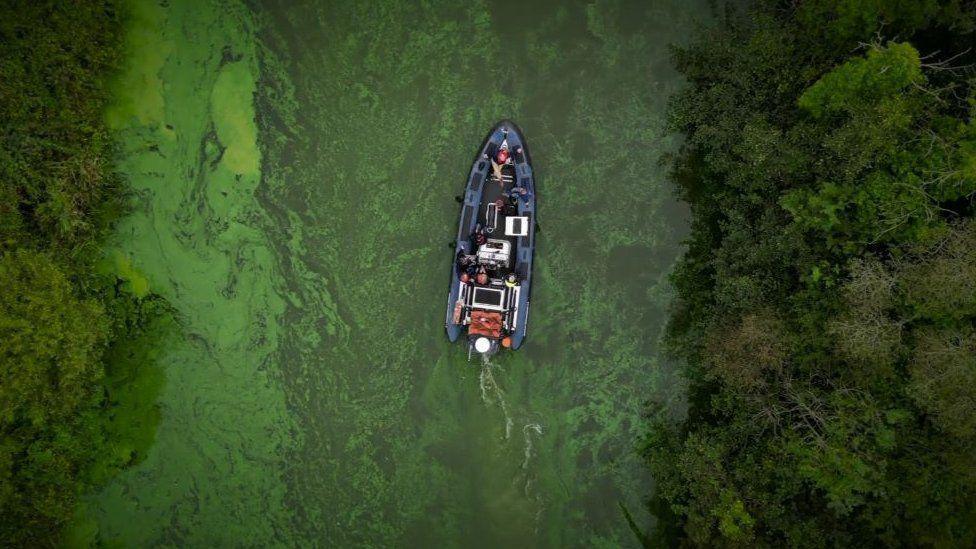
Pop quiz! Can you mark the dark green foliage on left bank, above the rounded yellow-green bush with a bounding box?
[0,1,122,247]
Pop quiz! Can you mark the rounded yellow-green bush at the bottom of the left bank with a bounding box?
[0,251,108,542]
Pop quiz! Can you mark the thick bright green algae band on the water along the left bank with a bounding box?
[90,0,295,546]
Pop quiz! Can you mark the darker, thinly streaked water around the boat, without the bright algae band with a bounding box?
[252,0,704,547]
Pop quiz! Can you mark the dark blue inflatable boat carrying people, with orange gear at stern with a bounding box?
[445,120,537,358]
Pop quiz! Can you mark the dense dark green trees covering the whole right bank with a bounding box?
[646,0,976,547]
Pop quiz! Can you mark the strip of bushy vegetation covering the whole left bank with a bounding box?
[0,0,164,546]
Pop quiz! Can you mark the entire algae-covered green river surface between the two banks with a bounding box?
[81,0,706,547]
